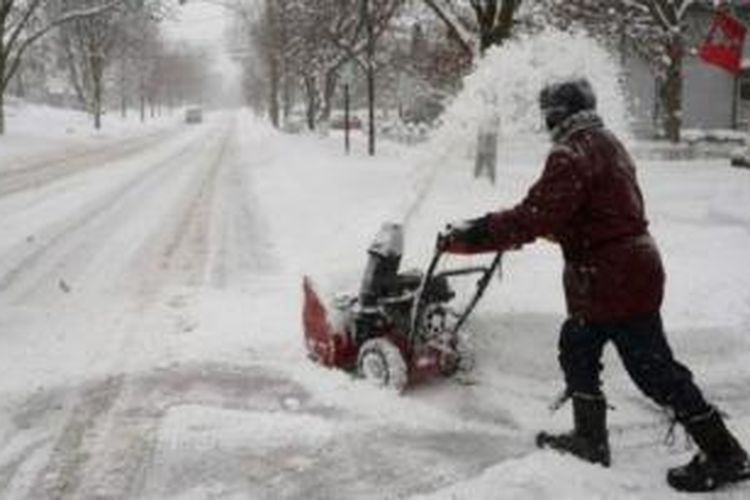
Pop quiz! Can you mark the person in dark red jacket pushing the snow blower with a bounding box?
[441,79,750,492]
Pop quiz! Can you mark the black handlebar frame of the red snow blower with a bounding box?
[409,233,503,343]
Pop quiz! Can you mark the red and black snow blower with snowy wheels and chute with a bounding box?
[303,224,501,392]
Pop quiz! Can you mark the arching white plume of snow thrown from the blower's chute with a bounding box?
[394,28,630,223]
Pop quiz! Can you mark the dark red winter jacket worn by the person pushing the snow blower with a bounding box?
[470,112,664,322]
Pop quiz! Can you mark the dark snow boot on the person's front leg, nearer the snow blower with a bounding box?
[536,393,610,467]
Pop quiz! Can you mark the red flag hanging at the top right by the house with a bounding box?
[698,10,747,74]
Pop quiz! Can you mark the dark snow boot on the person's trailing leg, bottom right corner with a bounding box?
[667,409,750,492]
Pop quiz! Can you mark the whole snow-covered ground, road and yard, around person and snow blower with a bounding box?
[0,112,750,500]
